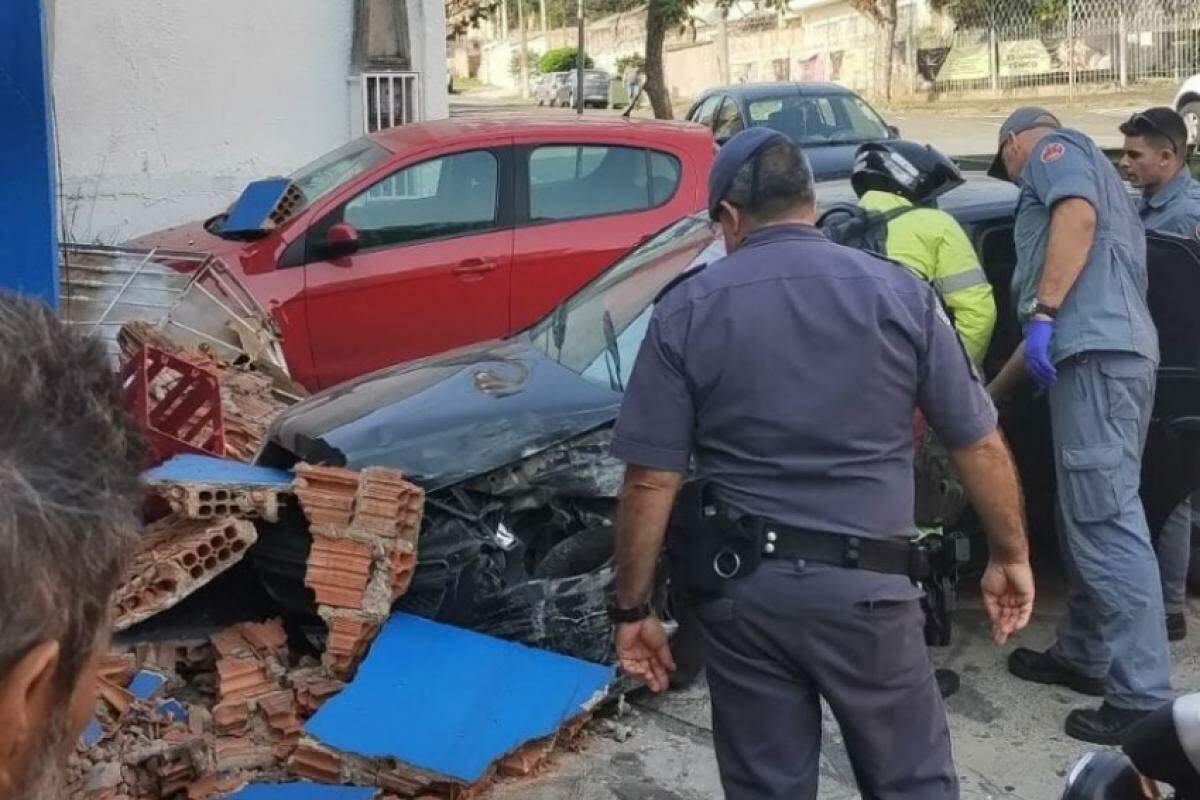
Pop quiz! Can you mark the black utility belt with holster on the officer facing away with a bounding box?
[667,480,955,595]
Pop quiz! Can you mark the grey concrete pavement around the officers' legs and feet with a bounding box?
[491,581,1200,800]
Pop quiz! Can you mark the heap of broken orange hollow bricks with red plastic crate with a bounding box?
[76,303,619,800]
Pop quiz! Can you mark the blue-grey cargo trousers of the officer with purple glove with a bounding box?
[1050,351,1171,709]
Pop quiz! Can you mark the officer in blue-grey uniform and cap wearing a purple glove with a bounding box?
[990,107,1171,745]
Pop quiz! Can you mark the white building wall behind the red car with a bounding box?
[53,0,446,243]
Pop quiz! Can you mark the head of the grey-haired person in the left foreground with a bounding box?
[0,291,140,800]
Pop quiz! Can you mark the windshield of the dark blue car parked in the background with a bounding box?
[748,95,889,146]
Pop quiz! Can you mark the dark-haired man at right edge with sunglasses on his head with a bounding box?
[1121,107,1200,642]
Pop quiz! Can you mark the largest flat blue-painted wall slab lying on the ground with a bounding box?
[305,614,613,782]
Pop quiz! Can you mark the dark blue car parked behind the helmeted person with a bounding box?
[686,83,900,180]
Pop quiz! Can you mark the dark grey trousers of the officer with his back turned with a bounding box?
[696,561,959,800]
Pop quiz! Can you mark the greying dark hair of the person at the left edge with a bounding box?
[0,291,142,691]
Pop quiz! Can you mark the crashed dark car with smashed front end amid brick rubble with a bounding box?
[254,174,1200,661]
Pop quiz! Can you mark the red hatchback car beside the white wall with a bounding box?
[131,115,714,390]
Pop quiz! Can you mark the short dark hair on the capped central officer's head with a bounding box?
[724,138,815,223]
